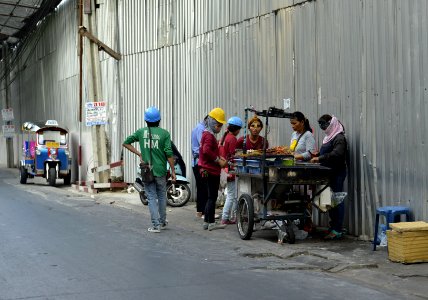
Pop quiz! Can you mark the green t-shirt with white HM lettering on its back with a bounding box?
[123,127,173,177]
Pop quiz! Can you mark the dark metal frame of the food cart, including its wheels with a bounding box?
[236,107,330,244]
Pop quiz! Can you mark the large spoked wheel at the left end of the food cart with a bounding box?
[236,194,254,240]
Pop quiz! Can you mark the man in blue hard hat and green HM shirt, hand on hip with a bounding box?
[123,106,176,232]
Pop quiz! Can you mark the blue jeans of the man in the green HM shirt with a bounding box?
[144,176,167,227]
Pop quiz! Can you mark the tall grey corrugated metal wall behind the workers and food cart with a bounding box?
[1,0,428,239]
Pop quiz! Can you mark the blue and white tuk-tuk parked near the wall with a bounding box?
[20,120,71,186]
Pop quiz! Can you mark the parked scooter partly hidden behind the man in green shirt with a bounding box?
[134,143,191,207]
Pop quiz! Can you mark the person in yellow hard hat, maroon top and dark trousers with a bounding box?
[198,107,227,231]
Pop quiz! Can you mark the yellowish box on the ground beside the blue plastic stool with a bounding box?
[386,221,428,264]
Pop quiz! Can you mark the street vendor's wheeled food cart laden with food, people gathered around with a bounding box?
[235,107,330,244]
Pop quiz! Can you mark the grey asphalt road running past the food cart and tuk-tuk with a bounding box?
[0,169,408,300]
